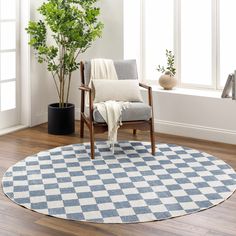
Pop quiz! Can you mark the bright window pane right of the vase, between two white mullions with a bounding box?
[181,0,212,85]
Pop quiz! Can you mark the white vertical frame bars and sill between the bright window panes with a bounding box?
[140,0,226,91]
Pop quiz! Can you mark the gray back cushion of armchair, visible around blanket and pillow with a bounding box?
[84,60,138,85]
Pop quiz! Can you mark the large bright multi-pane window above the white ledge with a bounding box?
[124,0,236,89]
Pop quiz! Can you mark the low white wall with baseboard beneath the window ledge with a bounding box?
[142,89,236,144]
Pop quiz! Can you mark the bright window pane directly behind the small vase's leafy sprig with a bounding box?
[143,0,174,80]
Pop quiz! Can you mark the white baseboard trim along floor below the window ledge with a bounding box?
[154,119,236,144]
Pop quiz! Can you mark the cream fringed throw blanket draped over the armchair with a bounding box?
[89,59,129,152]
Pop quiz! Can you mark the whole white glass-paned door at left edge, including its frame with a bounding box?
[0,0,20,130]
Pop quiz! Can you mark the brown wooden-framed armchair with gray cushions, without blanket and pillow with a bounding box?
[79,60,155,159]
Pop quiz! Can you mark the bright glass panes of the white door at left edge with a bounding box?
[0,0,17,112]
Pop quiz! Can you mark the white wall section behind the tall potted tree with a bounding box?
[30,0,123,126]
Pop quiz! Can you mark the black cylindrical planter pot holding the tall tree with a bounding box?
[48,103,75,134]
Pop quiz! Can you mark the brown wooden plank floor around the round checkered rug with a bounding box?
[0,123,236,236]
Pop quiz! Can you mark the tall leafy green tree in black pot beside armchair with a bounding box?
[26,0,103,134]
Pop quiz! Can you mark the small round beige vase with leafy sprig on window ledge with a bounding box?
[157,49,177,90]
